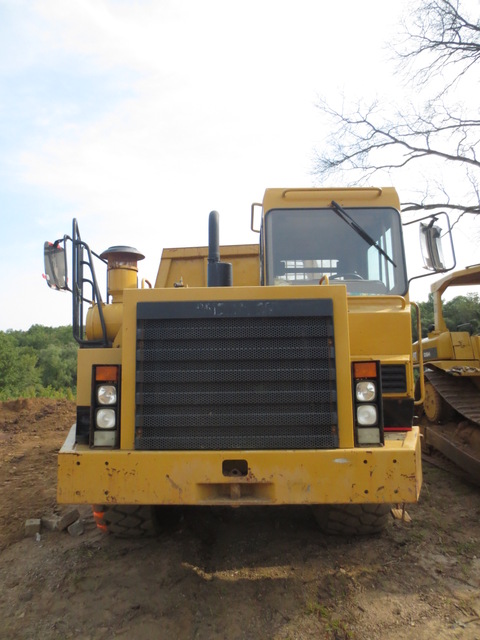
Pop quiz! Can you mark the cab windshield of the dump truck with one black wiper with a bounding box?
[265,205,407,295]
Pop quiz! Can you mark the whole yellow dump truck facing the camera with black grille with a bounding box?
[45,188,450,535]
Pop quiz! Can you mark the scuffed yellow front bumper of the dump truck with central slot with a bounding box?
[58,427,422,506]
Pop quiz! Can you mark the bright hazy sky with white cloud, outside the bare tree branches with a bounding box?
[0,0,478,330]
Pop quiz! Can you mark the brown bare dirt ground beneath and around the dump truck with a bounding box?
[0,400,480,640]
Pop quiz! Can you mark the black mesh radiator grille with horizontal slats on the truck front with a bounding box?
[135,300,338,450]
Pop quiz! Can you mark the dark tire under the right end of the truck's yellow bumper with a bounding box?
[313,503,392,536]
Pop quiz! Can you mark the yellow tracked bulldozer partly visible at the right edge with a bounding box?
[414,265,480,481]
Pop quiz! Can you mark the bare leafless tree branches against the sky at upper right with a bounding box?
[313,0,480,217]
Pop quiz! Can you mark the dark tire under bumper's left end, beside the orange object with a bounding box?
[93,504,157,538]
